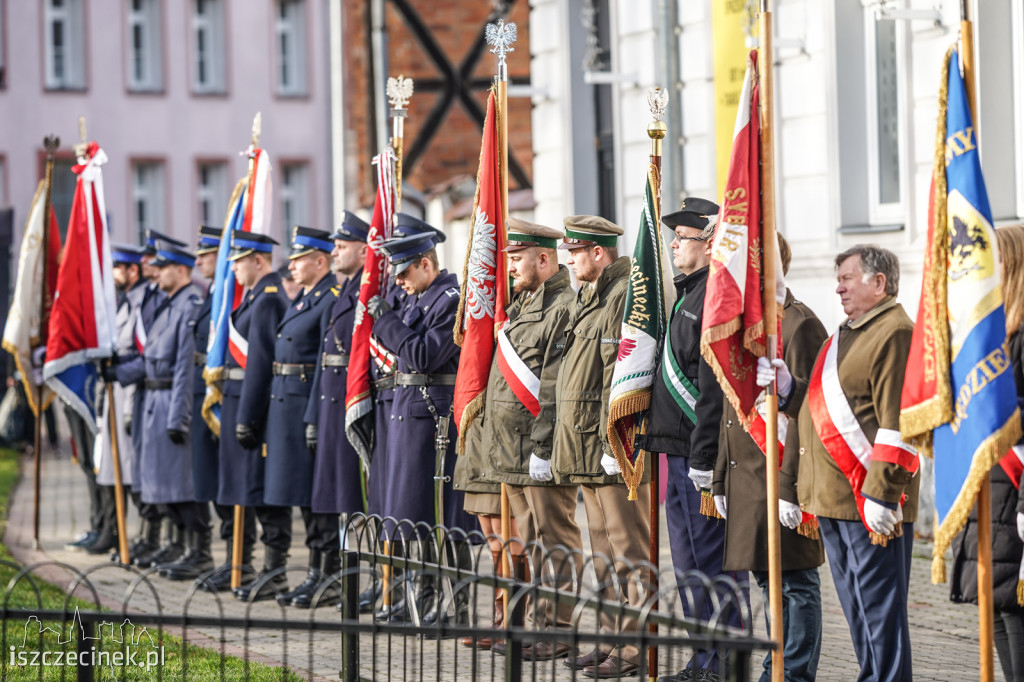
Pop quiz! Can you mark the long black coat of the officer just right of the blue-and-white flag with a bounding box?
[217,272,288,506]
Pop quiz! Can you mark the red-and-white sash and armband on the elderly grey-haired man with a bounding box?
[807,332,919,530]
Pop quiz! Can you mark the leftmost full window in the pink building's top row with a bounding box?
[43,0,85,90]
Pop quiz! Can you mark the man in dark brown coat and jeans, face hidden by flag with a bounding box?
[712,235,828,682]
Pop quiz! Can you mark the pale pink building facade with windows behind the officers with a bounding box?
[0,0,332,252]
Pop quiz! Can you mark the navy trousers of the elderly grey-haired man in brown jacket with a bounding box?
[818,517,913,682]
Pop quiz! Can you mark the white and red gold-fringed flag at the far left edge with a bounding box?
[3,179,60,416]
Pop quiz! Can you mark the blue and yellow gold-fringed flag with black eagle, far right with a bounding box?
[900,47,1021,582]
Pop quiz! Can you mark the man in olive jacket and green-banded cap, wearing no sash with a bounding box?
[551,215,650,678]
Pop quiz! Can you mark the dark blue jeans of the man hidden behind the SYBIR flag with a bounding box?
[752,568,821,682]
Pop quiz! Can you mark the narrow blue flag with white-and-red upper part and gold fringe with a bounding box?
[203,147,273,436]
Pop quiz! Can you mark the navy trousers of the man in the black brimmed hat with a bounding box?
[665,456,748,672]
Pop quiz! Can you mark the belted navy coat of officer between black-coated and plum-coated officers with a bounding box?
[260,274,337,507]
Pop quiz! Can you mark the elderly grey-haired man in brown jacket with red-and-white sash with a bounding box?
[773,245,921,682]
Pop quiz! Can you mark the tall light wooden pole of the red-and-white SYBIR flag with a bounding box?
[758,0,785,682]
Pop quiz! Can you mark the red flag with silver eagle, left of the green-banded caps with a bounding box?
[454,88,508,453]
